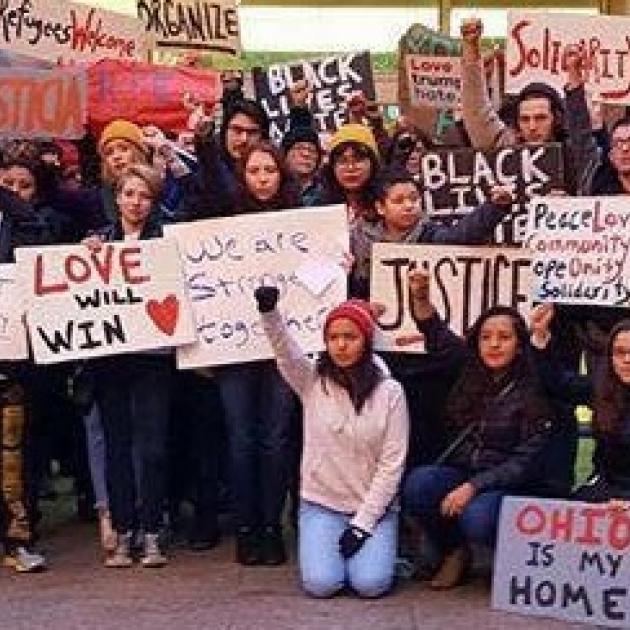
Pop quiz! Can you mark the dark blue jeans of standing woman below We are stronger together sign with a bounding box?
[217,361,295,527]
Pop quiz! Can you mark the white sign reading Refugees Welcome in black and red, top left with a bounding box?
[0,0,148,62]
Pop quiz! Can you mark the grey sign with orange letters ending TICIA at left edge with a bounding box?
[0,68,87,138]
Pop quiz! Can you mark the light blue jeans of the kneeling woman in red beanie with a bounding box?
[298,501,398,597]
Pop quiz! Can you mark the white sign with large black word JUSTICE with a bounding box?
[370,243,531,352]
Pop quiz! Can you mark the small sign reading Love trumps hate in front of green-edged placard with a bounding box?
[405,55,462,109]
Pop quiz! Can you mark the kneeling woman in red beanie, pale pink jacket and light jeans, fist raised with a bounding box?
[255,287,409,597]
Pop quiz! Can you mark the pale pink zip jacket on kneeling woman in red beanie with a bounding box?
[262,310,409,532]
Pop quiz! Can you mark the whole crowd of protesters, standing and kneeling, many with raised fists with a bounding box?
[0,20,630,597]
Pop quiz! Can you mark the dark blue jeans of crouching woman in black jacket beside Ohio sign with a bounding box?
[403,466,505,552]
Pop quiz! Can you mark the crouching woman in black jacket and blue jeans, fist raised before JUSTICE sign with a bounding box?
[403,272,552,589]
